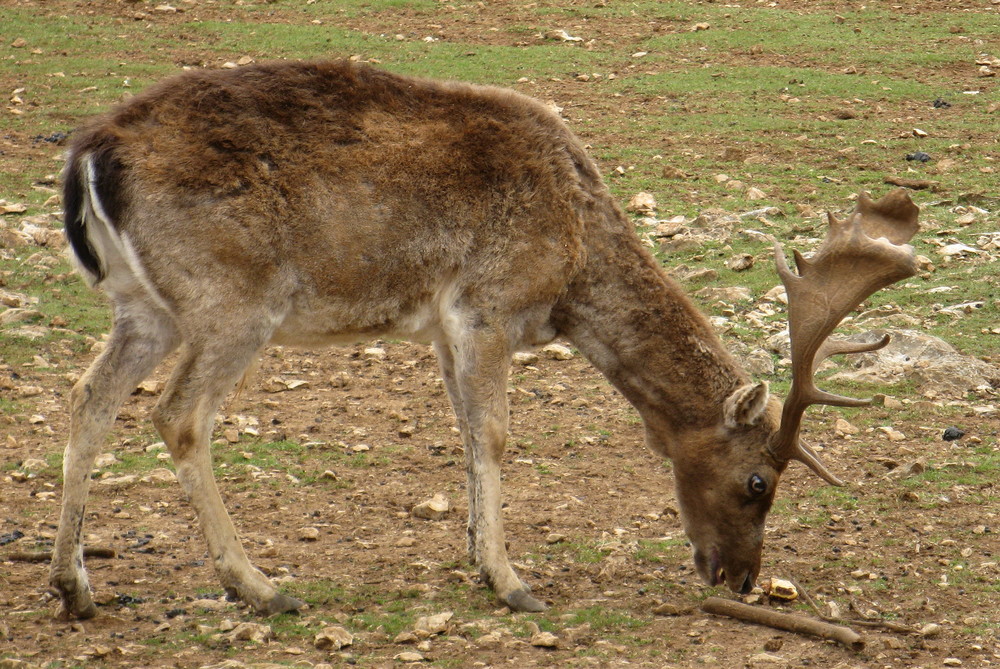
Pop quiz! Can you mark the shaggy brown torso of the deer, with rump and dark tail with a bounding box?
[66,62,588,345]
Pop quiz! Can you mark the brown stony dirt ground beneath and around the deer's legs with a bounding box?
[0,2,1000,667]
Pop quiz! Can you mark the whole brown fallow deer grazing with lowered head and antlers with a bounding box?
[50,62,917,618]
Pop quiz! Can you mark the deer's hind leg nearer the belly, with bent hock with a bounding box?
[153,328,303,616]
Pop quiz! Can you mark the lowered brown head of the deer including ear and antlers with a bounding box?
[674,190,918,592]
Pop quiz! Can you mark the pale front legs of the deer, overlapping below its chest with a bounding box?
[435,328,545,611]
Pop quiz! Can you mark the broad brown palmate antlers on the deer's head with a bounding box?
[770,190,919,485]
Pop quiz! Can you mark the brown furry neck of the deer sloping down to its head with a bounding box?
[554,206,749,455]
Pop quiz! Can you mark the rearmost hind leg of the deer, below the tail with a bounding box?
[49,303,176,619]
